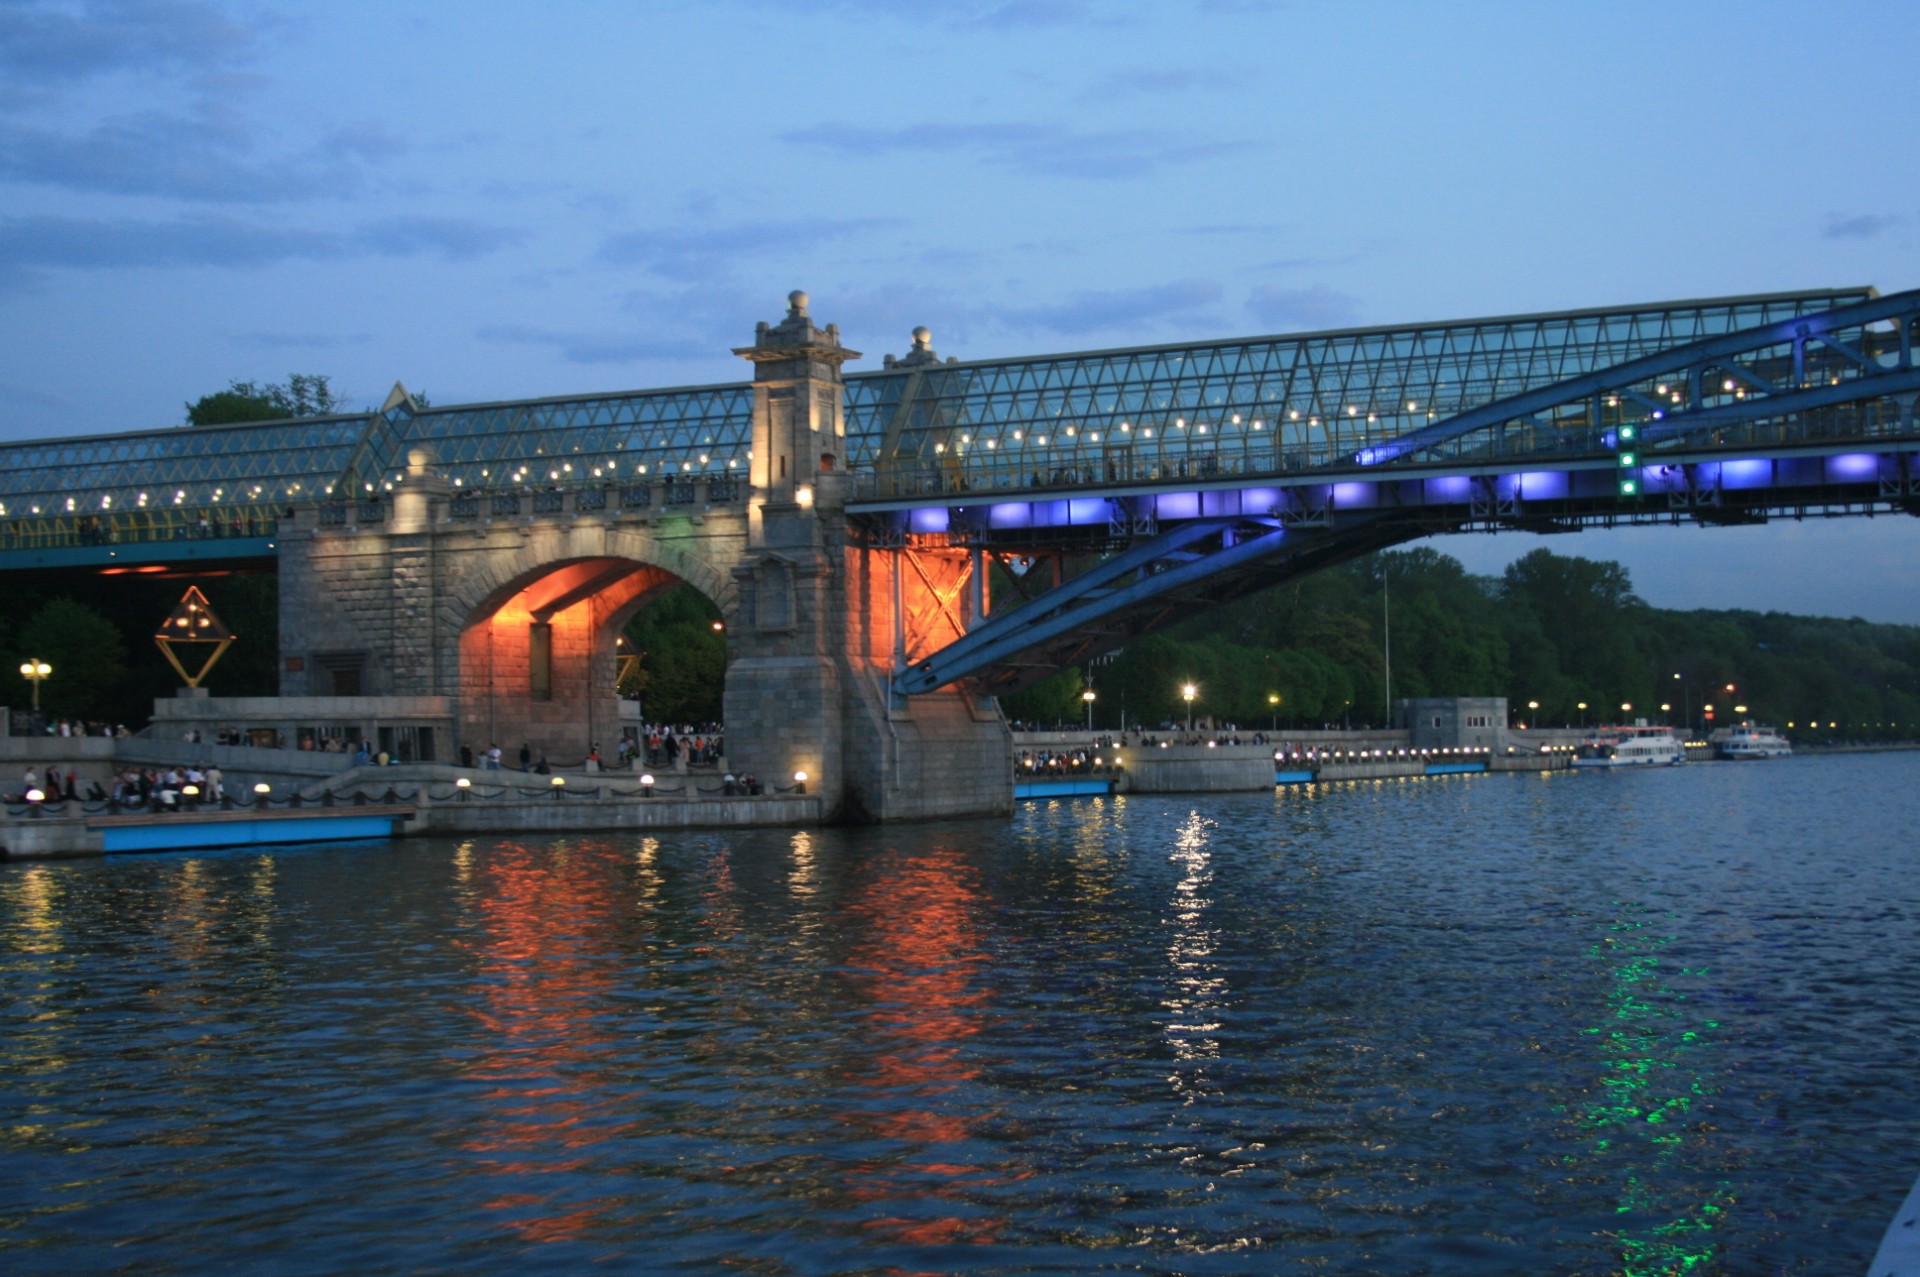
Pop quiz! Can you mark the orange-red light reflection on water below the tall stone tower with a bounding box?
[841,847,1027,1244]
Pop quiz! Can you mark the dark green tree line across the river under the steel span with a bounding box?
[1004,547,1920,739]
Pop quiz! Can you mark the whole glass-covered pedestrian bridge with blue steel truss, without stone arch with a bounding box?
[0,288,1920,695]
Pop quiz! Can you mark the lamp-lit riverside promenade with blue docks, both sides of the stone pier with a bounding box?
[0,732,1569,860]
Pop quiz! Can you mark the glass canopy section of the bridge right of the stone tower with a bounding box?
[847,288,1872,492]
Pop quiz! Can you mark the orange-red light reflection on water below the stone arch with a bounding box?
[463,849,632,1242]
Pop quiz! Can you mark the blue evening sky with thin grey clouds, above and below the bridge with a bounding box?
[0,0,1920,622]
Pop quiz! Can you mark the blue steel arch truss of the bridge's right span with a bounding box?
[897,290,1920,695]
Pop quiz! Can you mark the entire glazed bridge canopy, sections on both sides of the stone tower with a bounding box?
[0,288,1872,518]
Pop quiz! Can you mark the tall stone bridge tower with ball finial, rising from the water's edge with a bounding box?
[726,292,1014,820]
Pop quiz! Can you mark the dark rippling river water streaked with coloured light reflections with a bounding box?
[0,755,1920,1273]
